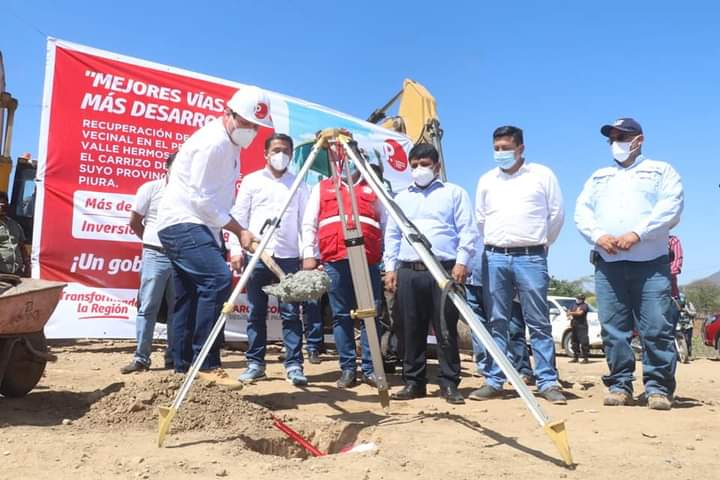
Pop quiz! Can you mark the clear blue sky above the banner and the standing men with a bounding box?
[0,0,720,283]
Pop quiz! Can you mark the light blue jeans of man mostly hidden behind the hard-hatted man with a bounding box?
[135,248,175,367]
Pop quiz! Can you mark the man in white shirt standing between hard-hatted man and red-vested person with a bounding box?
[230,133,309,385]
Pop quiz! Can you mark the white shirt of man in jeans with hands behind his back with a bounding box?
[475,163,565,247]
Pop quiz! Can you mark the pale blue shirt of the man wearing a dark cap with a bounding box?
[575,155,683,262]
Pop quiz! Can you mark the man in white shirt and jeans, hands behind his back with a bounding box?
[469,126,566,404]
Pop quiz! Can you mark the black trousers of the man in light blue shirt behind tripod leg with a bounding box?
[396,262,460,387]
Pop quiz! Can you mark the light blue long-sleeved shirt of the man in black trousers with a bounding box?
[384,179,479,272]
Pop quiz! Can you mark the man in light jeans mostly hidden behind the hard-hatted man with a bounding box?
[120,153,175,374]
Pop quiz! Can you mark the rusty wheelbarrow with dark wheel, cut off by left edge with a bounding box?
[0,275,65,397]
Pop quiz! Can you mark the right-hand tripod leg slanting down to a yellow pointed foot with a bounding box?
[338,136,573,465]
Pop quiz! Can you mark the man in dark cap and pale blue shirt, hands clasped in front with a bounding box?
[575,118,683,410]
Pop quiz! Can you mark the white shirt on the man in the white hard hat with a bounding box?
[157,119,240,245]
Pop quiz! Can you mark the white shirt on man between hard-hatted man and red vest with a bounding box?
[228,167,309,258]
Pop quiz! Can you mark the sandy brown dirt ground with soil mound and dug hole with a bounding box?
[0,341,720,480]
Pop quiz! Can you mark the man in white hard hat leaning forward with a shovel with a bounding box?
[157,87,272,386]
